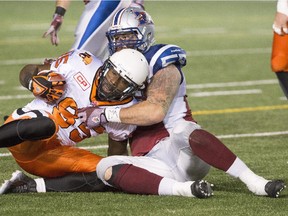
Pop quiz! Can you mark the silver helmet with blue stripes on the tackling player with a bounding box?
[106,7,155,54]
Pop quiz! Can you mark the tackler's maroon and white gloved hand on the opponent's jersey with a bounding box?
[78,106,108,128]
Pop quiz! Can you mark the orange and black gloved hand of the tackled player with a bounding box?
[29,71,66,102]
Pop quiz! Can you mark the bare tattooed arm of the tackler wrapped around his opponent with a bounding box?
[117,64,181,125]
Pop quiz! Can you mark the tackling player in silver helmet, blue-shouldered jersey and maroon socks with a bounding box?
[79,8,285,197]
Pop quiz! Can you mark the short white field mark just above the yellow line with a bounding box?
[188,89,262,97]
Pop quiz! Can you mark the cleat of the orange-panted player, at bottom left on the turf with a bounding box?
[0,170,37,194]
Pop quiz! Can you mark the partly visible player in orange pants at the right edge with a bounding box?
[271,0,288,99]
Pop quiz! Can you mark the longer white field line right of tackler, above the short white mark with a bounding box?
[186,79,278,89]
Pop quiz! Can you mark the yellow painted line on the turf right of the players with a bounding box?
[192,105,288,115]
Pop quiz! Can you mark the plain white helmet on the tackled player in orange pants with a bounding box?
[97,48,149,101]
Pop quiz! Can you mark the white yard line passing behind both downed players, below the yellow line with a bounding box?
[0,131,288,157]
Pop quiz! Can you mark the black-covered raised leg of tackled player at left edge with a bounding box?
[0,117,56,147]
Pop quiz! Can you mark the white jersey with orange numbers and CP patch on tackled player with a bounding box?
[24,50,136,146]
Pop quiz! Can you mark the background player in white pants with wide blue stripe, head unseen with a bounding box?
[43,0,144,60]
